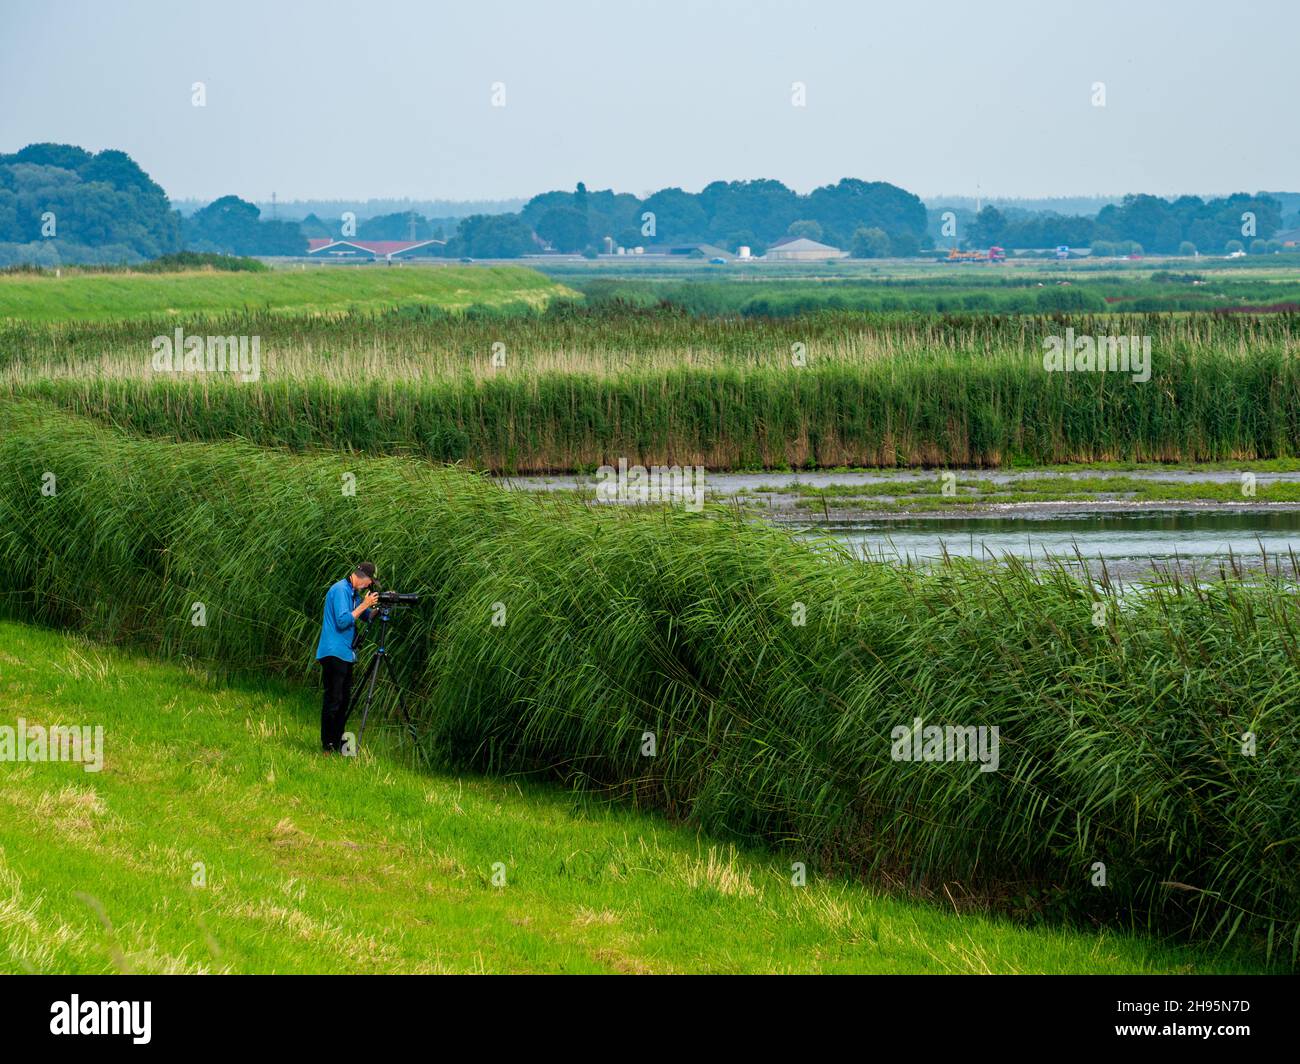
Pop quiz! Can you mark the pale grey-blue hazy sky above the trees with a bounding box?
[0,0,1300,199]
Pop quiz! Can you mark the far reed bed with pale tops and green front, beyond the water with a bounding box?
[0,308,1300,473]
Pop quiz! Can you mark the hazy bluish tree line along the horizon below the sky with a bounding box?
[0,143,1284,265]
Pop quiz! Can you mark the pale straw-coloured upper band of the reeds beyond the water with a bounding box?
[0,302,1300,382]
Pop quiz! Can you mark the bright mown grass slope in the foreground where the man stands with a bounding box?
[0,622,1257,973]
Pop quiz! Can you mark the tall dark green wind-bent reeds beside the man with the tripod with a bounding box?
[0,401,1300,966]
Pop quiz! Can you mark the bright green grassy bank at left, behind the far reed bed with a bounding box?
[0,265,572,321]
